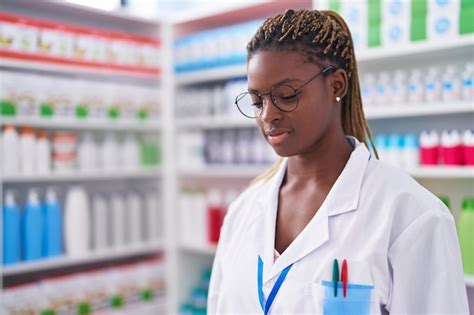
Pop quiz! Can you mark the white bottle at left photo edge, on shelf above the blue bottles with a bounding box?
[1,125,20,175]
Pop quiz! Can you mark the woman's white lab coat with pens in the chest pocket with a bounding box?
[208,137,469,314]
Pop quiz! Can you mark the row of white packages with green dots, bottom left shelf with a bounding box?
[0,260,166,315]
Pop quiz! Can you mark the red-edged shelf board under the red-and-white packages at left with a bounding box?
[0,49,160,80]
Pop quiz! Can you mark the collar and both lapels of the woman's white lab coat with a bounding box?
[255,136,370,283]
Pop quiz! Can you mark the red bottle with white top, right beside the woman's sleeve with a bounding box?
[207,189,225,244]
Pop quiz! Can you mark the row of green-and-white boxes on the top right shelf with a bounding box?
[317,0,474,49]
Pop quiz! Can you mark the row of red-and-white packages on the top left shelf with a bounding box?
[0,12,160,68]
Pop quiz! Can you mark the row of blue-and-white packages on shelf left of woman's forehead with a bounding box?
[174,21,262,73]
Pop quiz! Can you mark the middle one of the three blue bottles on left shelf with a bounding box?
[22,190,43,261]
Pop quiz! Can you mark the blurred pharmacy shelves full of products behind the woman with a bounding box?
[0,0,474,315]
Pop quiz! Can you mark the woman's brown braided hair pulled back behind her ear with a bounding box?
[247,9,378,182]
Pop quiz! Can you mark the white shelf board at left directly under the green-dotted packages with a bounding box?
[0,116,161,132]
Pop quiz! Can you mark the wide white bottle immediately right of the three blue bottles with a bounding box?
[64,186,91,258]
